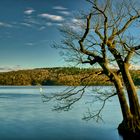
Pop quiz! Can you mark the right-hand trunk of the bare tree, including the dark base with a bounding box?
[118,64,140,136]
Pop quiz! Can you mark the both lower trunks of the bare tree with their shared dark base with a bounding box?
[101,61,140,136]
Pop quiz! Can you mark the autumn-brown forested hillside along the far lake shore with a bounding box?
[0,67,140,86]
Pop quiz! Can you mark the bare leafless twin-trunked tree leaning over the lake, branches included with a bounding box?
[44,0,140,137]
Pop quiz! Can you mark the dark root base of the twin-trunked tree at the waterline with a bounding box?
[118,119,140,140]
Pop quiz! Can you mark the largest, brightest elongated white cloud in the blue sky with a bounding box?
[39,13,64,21]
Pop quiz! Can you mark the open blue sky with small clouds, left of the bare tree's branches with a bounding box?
[0,0,86,71]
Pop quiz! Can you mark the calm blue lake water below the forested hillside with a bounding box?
[0,86,139,140]
